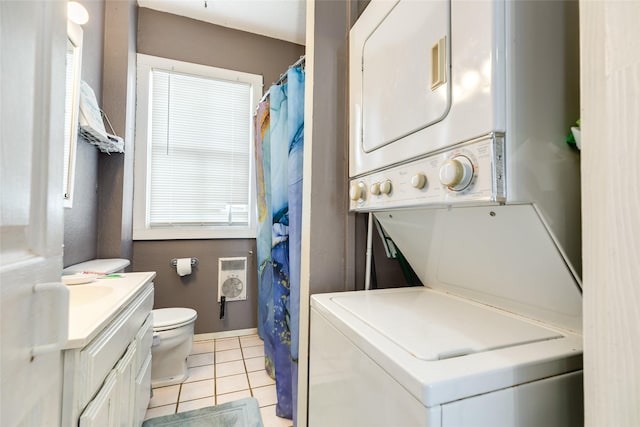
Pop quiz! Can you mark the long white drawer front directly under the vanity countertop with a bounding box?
[78,284,153,407]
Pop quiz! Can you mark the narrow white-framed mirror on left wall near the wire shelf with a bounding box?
[63,21,82,208]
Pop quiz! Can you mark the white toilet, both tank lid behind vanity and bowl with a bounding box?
[62,258,198,388]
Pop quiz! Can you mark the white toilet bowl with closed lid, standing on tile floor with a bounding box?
[151,308,198,388]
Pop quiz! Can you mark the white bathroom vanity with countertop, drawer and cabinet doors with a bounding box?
[62,272,156,427]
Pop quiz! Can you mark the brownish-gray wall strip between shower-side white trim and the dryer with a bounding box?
[300,0,356,294]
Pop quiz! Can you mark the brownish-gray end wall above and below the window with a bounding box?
[132,8,304,333]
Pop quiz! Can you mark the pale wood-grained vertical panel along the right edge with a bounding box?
[580,0,640,427]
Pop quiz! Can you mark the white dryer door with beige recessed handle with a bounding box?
[359,0,451,153]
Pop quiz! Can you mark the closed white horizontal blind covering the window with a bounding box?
[148,69,251,228]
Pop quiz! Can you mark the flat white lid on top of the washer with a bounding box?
[332,287,562,361]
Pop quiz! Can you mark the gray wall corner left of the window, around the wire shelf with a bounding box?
[64,0,137,267]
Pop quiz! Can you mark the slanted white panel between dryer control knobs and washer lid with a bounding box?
[376,204,582,331]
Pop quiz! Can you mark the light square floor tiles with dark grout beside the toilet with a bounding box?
[145,335,293,427]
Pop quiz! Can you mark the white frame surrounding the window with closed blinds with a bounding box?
[132,53,263,240]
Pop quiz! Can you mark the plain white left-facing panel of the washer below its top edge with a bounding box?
[309,307,440,427]
